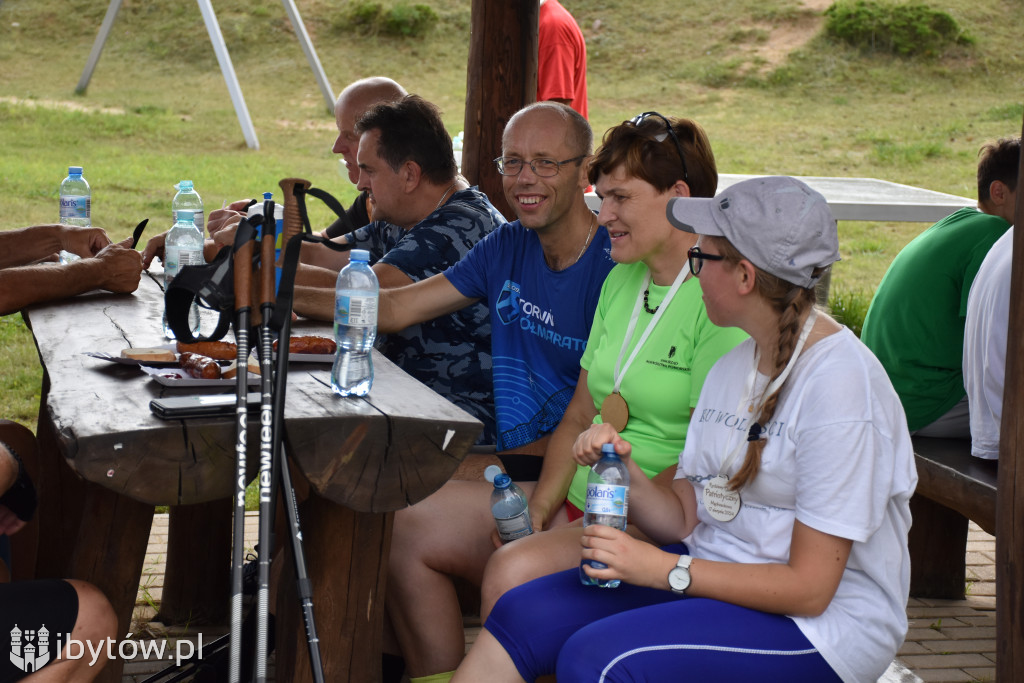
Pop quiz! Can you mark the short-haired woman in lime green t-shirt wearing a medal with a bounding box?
[481,113,746,617]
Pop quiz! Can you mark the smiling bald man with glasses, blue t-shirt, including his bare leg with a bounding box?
[364,101,613,680]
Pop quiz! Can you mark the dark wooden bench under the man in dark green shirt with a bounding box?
[909,436,997,599]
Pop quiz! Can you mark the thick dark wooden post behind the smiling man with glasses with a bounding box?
[462,0,541,219]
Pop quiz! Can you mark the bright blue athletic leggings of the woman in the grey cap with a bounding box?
[484,544,840,683]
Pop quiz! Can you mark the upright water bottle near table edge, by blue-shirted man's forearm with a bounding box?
[331,249,380,396]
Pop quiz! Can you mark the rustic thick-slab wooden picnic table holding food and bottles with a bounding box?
[25,273,481,681]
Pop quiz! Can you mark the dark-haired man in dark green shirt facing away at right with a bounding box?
[861,137,1021,437]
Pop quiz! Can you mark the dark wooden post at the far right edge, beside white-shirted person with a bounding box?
[995,112,1024,681]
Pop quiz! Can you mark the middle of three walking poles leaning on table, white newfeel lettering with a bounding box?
[253,194,276,683]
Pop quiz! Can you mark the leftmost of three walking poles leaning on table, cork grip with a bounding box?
[228,220,253,683]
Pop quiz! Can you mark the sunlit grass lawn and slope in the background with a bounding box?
[0,0,1024,428]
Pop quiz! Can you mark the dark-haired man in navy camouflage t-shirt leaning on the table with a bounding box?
[295,95,505,444]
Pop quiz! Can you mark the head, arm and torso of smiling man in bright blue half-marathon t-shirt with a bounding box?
[366,102,613,455]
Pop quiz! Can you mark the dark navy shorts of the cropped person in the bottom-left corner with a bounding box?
[0,581,78,683]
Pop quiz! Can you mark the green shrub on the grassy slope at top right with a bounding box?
[825,0,974,56]
